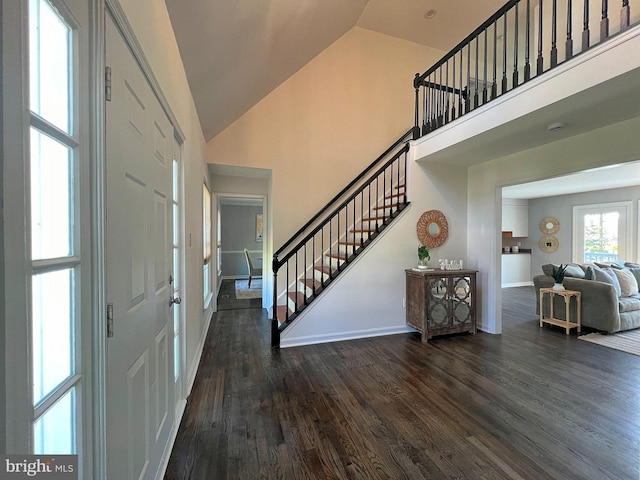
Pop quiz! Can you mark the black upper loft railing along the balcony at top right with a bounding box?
[413,0,636,139]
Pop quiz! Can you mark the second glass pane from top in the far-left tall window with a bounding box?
[31,128,72,260]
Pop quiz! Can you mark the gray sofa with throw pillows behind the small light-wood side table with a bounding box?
[533,263,640,333]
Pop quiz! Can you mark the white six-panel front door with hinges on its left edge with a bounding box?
[106,18,175,480]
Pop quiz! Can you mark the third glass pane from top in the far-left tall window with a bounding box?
[32,269,74,404]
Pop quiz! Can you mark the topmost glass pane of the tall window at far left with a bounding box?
[29,0,71,133]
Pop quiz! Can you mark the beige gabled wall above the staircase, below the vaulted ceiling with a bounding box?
[207,27,442,249]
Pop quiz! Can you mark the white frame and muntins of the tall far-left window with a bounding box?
[0,0,97,472]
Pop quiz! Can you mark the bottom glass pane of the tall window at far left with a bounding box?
[33,388,76,455]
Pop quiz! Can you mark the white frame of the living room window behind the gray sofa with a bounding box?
[572,201,635,263]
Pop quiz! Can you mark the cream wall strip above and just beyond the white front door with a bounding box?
[120,0,212,390]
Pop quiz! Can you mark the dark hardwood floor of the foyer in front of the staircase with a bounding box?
[165,287,640,480]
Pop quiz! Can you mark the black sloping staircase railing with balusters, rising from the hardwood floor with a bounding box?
[271,128,413,347]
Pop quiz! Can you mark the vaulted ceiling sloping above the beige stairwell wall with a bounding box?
[165,0,505,141]
